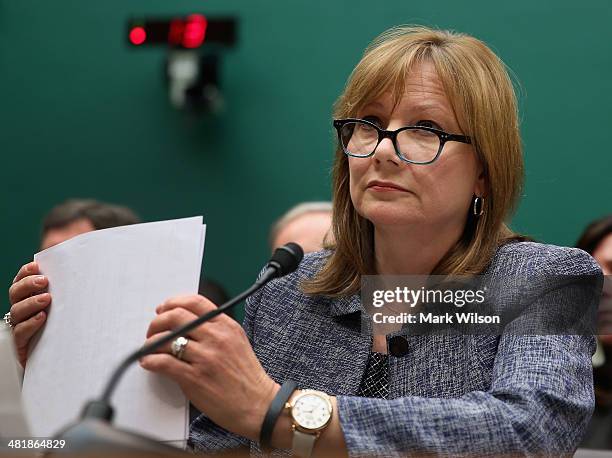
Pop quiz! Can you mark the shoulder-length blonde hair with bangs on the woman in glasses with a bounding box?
[302,26,523,296]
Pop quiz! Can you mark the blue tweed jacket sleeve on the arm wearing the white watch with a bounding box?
[337,250,601,456]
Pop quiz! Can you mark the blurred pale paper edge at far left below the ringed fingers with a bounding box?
[0,325,30,439]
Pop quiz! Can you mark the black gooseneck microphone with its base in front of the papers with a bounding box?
[50,243,304,454]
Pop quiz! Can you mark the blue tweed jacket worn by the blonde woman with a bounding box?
[190,242,601,456]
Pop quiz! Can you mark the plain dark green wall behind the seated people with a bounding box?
[0,0,612,320]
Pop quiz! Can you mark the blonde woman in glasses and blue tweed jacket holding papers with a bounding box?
[11,27,599,456]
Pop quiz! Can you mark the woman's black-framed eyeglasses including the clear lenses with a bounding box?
[334,118,472,164]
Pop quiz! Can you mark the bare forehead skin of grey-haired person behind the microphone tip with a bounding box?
[272,212,331,253]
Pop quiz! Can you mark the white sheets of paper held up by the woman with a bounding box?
[23,216,206,441]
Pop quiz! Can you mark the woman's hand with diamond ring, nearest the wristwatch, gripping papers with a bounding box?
[140,296,280,440]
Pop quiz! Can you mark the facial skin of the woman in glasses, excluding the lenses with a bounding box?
[348,63,484,235]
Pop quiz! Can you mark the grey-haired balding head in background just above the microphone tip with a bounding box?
[270,202,332,253]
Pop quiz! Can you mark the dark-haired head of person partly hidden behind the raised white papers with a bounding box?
[40,199,140,250]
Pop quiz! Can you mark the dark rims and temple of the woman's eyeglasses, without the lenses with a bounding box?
[333,118,472,165]
